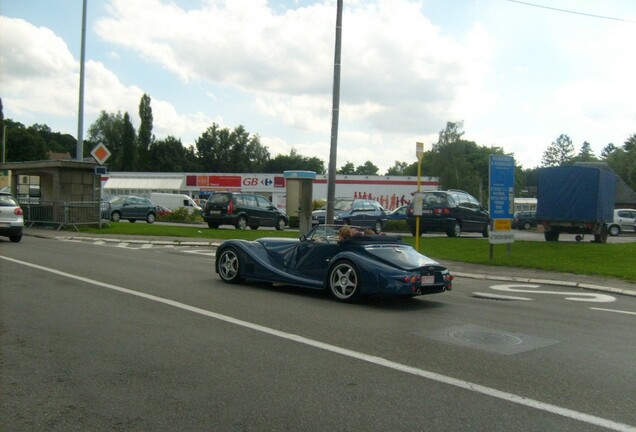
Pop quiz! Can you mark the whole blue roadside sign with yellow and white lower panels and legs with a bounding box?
[488,155,515,259]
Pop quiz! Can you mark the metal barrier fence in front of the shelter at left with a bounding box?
[20,201,108,230]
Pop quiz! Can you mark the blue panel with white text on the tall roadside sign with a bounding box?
[490,155,515,223]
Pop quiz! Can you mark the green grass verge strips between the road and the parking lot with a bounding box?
[80,222,636,282]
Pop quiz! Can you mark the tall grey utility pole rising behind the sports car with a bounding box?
[325,0,343,224]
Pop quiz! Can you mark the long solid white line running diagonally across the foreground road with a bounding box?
[0,255,636,432]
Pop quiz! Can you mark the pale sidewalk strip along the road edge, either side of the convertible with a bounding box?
[24,228,636,297]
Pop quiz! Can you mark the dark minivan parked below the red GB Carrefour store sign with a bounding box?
[203,192,289,231]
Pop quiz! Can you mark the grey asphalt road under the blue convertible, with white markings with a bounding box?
[0,236,636,431]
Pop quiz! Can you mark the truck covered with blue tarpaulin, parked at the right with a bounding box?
[537,165,616,243]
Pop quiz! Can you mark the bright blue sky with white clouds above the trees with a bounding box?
[0,0,636,175]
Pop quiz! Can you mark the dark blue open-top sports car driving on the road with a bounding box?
[215,225,453,302]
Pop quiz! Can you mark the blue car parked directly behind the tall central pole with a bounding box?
[311,198,387,234]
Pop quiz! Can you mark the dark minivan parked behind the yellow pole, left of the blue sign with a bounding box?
[406,189,490,237]
